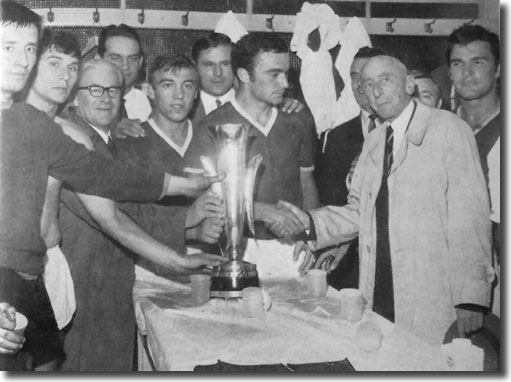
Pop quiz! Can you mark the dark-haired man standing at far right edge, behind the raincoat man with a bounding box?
[447,25,502,316]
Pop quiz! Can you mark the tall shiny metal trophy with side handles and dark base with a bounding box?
[200,124,262,298]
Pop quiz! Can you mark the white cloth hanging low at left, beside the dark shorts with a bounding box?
[43,246,76,329]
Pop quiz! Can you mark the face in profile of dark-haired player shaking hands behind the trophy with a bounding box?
[248,52,289,106]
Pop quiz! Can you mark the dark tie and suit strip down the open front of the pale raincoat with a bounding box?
[373,126,394,322]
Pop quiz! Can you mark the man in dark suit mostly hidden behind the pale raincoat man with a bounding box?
[314,46,385,289]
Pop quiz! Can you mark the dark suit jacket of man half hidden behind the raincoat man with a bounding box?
[315,116,364,289]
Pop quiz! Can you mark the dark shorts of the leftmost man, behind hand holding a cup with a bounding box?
[0,267,65,371]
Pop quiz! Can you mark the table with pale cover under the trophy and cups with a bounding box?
[134,279,447,371]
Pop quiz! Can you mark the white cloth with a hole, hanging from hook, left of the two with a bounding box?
[290,2,342,136]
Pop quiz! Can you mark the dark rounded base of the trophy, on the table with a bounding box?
[210,260,259,298]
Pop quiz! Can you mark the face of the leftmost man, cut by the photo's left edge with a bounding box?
[0,24,39,97]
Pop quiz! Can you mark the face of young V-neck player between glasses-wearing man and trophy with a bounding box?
[152,68,199,123]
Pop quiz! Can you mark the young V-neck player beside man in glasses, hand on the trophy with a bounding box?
[115,54,223,286]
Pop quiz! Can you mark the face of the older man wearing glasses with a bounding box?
[76,66,122,130]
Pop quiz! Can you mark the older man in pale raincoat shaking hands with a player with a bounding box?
[281,56,493,345]
